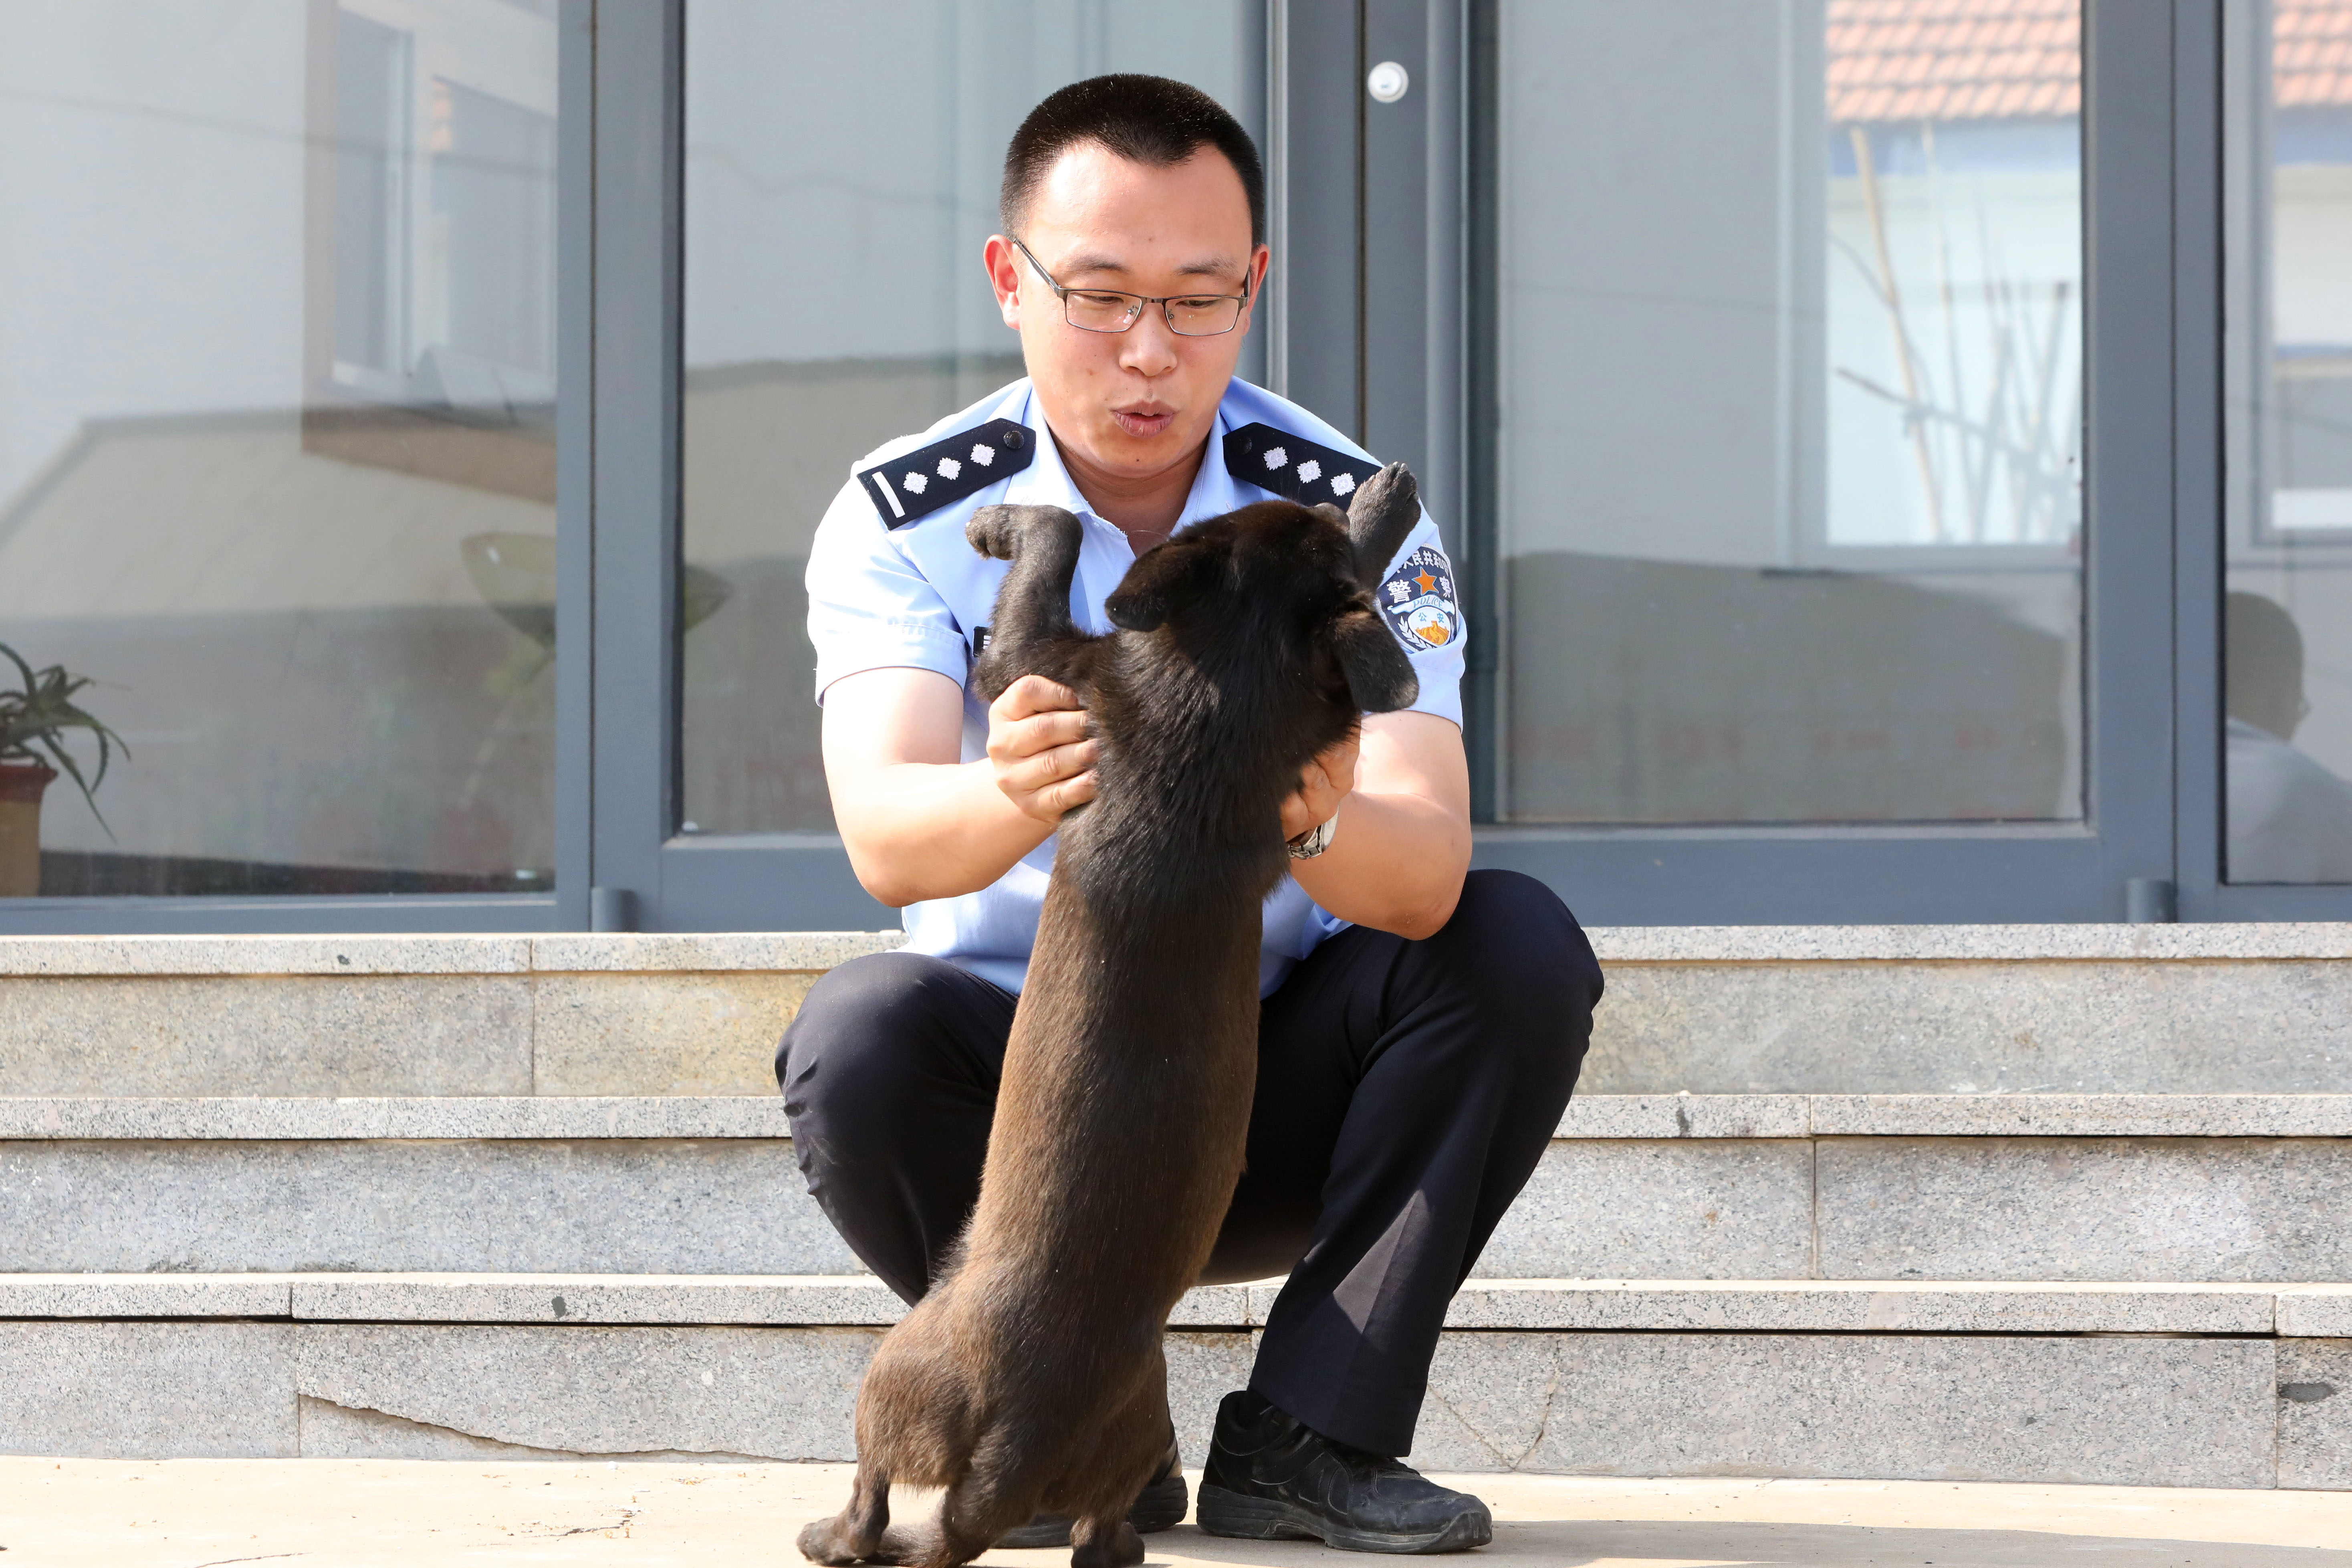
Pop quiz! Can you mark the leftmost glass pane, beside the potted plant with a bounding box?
[0,0,555,896]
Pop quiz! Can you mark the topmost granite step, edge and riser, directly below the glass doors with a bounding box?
[0,924,2352,1096]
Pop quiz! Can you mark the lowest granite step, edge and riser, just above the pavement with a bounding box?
[0,1274,2352,1490]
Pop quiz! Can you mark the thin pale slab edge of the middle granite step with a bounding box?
[0,1093,2352,1140]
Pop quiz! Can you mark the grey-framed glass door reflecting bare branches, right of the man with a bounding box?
[1473,0,2171,924]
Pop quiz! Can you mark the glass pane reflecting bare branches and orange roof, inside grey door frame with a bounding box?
[1496,0,2084,823]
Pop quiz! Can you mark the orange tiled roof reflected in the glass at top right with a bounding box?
[1828,0,2352,125]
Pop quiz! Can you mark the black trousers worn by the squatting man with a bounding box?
[776,870,1602,1455]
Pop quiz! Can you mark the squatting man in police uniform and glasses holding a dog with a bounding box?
[776,75,1602,1552]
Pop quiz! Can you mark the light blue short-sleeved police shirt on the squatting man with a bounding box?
[809,379,1465,997]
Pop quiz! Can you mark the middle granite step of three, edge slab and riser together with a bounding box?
[14,1096,2352,1283]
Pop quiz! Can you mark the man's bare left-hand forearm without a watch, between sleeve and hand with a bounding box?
[835,759,1054,907]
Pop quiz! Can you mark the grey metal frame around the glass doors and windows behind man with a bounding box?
[0,0,2352,933]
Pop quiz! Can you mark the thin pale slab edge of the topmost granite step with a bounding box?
[0,922,2352,978]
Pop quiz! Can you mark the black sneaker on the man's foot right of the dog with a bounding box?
[1200,1392,1493,1554]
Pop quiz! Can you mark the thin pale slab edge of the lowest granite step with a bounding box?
[18,1274,2352,1340]
